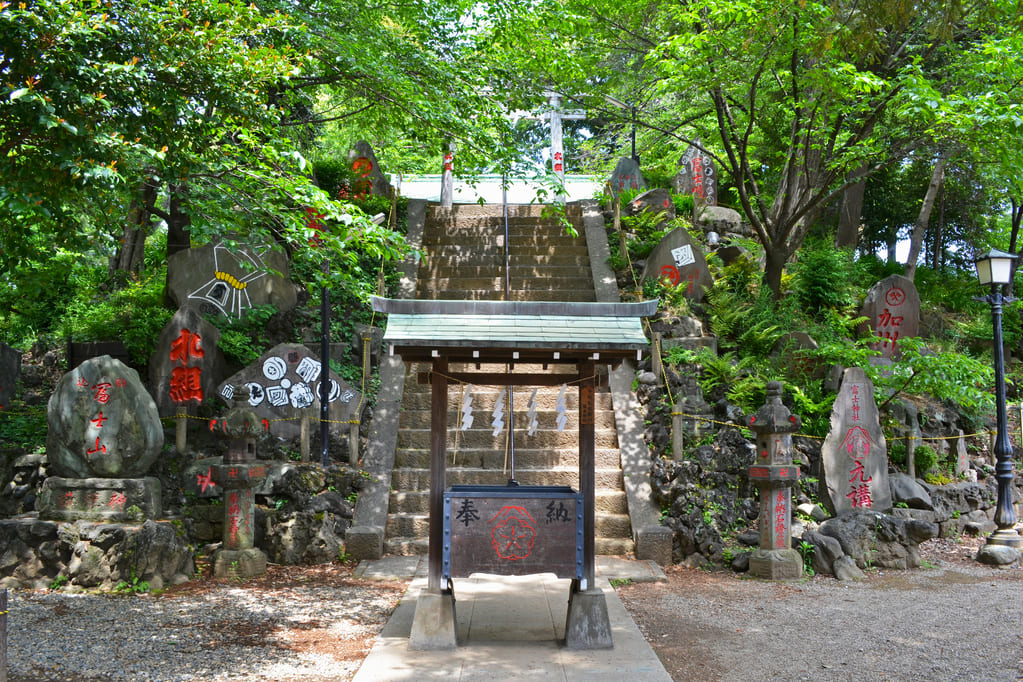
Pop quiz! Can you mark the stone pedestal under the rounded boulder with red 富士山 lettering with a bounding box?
[36,476,164,521]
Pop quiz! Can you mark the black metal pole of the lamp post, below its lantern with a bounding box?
[987,284,1023,547]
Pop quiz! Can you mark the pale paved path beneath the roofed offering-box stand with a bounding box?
[354,556,671,682]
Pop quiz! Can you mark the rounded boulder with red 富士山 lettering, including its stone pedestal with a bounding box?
[38,356,164,520]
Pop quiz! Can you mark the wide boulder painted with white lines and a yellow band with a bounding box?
[167,243,298,318]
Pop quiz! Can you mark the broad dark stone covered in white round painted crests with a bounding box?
[217,344,362,438]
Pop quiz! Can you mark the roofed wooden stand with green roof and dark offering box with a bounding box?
[373,298,657,648]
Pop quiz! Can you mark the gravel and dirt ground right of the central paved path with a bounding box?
[619,541,1023,681]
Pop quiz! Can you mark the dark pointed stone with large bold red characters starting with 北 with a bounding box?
[149,306,226,416]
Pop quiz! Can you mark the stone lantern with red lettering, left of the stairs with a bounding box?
[211,408,266,578]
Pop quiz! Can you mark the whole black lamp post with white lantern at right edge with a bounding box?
[974,248,1023,559]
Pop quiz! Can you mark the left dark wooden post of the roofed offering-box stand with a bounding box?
[427,358,448,592]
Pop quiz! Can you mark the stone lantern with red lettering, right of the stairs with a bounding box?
[750,381,803,580]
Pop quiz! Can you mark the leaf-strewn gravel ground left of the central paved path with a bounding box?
[0,564,407,682]
